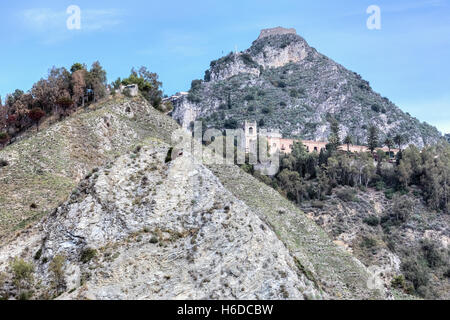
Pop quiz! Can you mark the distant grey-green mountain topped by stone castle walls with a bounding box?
[172,29,441,147]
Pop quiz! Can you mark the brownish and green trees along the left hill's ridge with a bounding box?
[0,61,162,147]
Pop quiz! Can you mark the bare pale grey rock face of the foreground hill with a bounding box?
[0,141,323,299]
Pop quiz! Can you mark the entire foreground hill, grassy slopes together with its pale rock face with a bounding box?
[0,99,396,299]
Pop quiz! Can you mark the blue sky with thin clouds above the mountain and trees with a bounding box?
[0,0,450,132]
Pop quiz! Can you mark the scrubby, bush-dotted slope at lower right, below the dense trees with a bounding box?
[301,188,450,299]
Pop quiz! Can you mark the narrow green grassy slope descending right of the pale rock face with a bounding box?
[207,165,386,299]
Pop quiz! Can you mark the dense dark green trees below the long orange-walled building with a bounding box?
[244,121,450,213]
